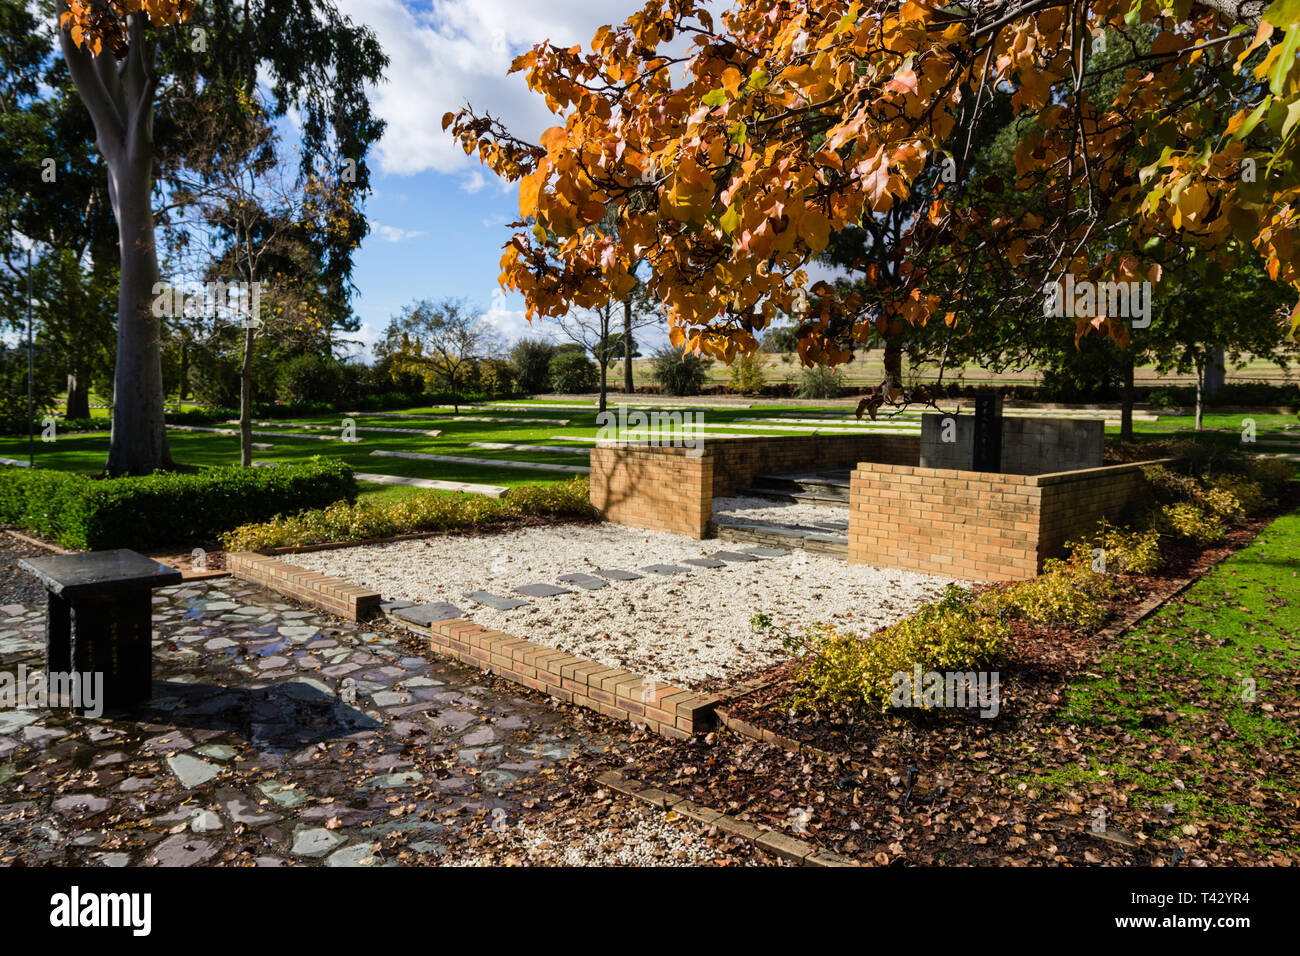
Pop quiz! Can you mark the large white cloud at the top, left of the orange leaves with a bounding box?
[330,0,642,178]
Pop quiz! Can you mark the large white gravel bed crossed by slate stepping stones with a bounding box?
[297,524,967,688]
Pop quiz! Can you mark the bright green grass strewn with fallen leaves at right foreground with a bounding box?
[1024,510,1300,847]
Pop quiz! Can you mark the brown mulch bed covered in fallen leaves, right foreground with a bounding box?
[595,499,1295,866]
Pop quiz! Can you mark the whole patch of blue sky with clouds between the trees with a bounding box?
[330,0,655,358]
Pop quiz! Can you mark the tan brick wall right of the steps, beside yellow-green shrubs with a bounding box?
[849,462,1151,581]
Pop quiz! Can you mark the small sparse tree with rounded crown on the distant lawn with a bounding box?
[374,299,501,415]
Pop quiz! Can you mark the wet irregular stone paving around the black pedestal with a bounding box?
[0,579,628,866]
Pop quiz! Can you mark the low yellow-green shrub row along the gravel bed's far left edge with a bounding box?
[221,477,595,550]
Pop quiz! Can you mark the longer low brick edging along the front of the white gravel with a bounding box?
[389,615,718,740]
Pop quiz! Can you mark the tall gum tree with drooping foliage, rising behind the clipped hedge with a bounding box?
[56,0,387,475]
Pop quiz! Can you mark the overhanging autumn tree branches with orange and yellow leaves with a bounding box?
[443,0,1300,401]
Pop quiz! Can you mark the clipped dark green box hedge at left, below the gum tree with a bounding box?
[0,458,356,550]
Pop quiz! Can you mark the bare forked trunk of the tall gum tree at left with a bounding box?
[59,14,172,475]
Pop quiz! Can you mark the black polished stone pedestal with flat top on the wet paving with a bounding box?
[18,549,182,710]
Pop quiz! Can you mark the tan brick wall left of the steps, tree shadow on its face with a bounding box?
[590,434,920,538]
